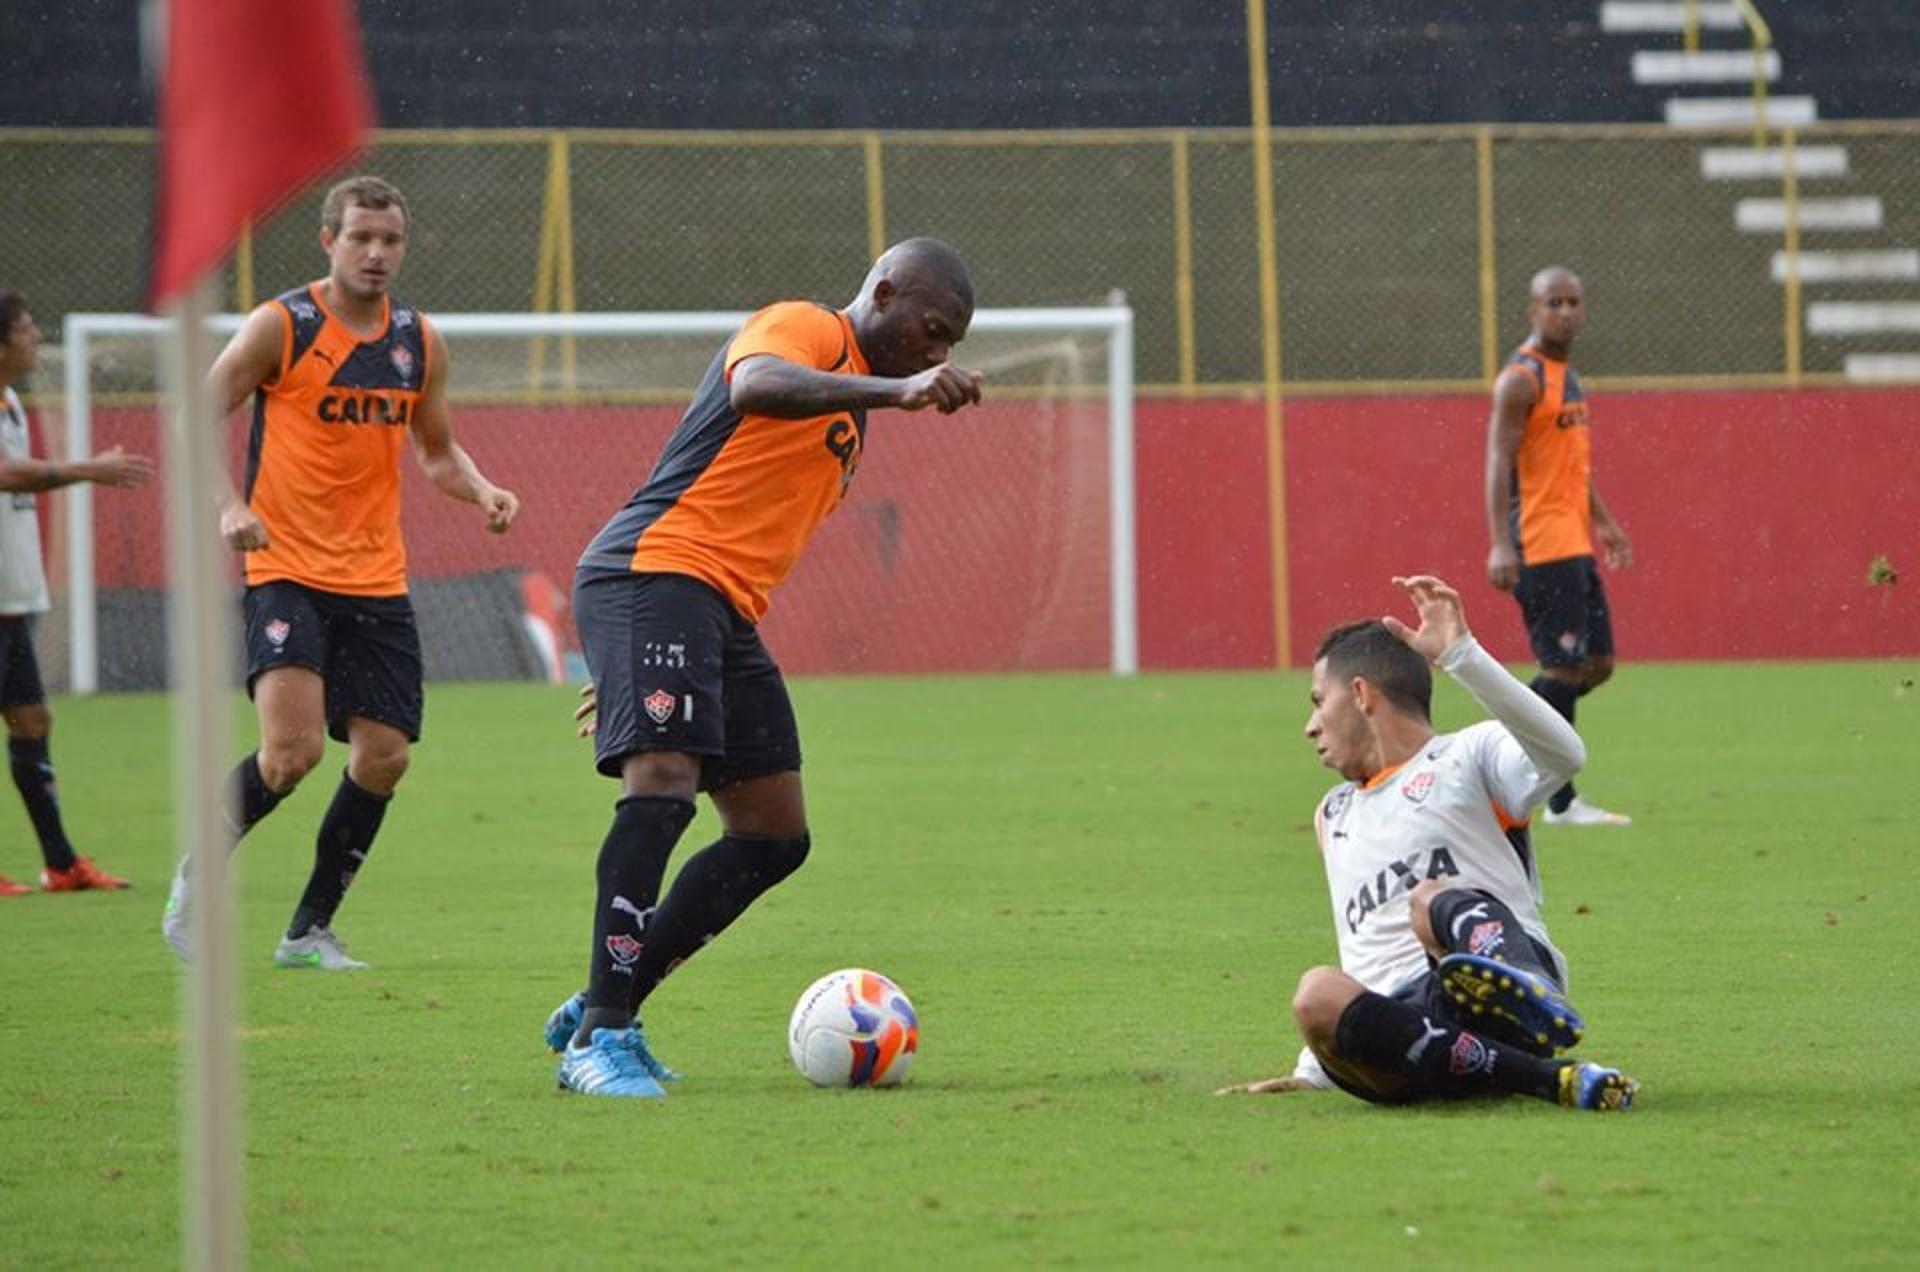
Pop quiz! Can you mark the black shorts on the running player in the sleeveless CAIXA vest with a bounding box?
[246,578,424,742]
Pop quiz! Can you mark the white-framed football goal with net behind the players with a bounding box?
[45,306,1137,692]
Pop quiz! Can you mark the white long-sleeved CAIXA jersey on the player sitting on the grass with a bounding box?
[1296,636,1586,1076]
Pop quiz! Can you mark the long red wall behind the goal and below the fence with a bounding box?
[78,388,1920,673]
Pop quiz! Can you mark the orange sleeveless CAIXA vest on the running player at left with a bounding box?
[246,282,428,596]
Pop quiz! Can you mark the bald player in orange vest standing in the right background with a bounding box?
[1486,265,1634,826]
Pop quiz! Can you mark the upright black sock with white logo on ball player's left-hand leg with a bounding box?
[574,795,693,1045]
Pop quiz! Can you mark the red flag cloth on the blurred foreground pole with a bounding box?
[154,0,372,307]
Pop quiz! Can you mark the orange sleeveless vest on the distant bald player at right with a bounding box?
[1507,344,1594,565]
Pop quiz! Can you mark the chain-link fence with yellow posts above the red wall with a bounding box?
[0,121,1920,394]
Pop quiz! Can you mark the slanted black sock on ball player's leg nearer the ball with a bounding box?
[630,834,812,1011]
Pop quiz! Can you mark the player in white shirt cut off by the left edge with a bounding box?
[0,288,154,897]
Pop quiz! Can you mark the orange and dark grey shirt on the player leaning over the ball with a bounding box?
[580,300,868,623]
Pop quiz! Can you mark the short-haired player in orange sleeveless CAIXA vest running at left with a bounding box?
[163,177,520,970]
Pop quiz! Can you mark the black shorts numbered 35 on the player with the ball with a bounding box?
[574,575,801,790]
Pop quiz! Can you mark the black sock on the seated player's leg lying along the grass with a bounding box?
[1334,991,1563,1101]
